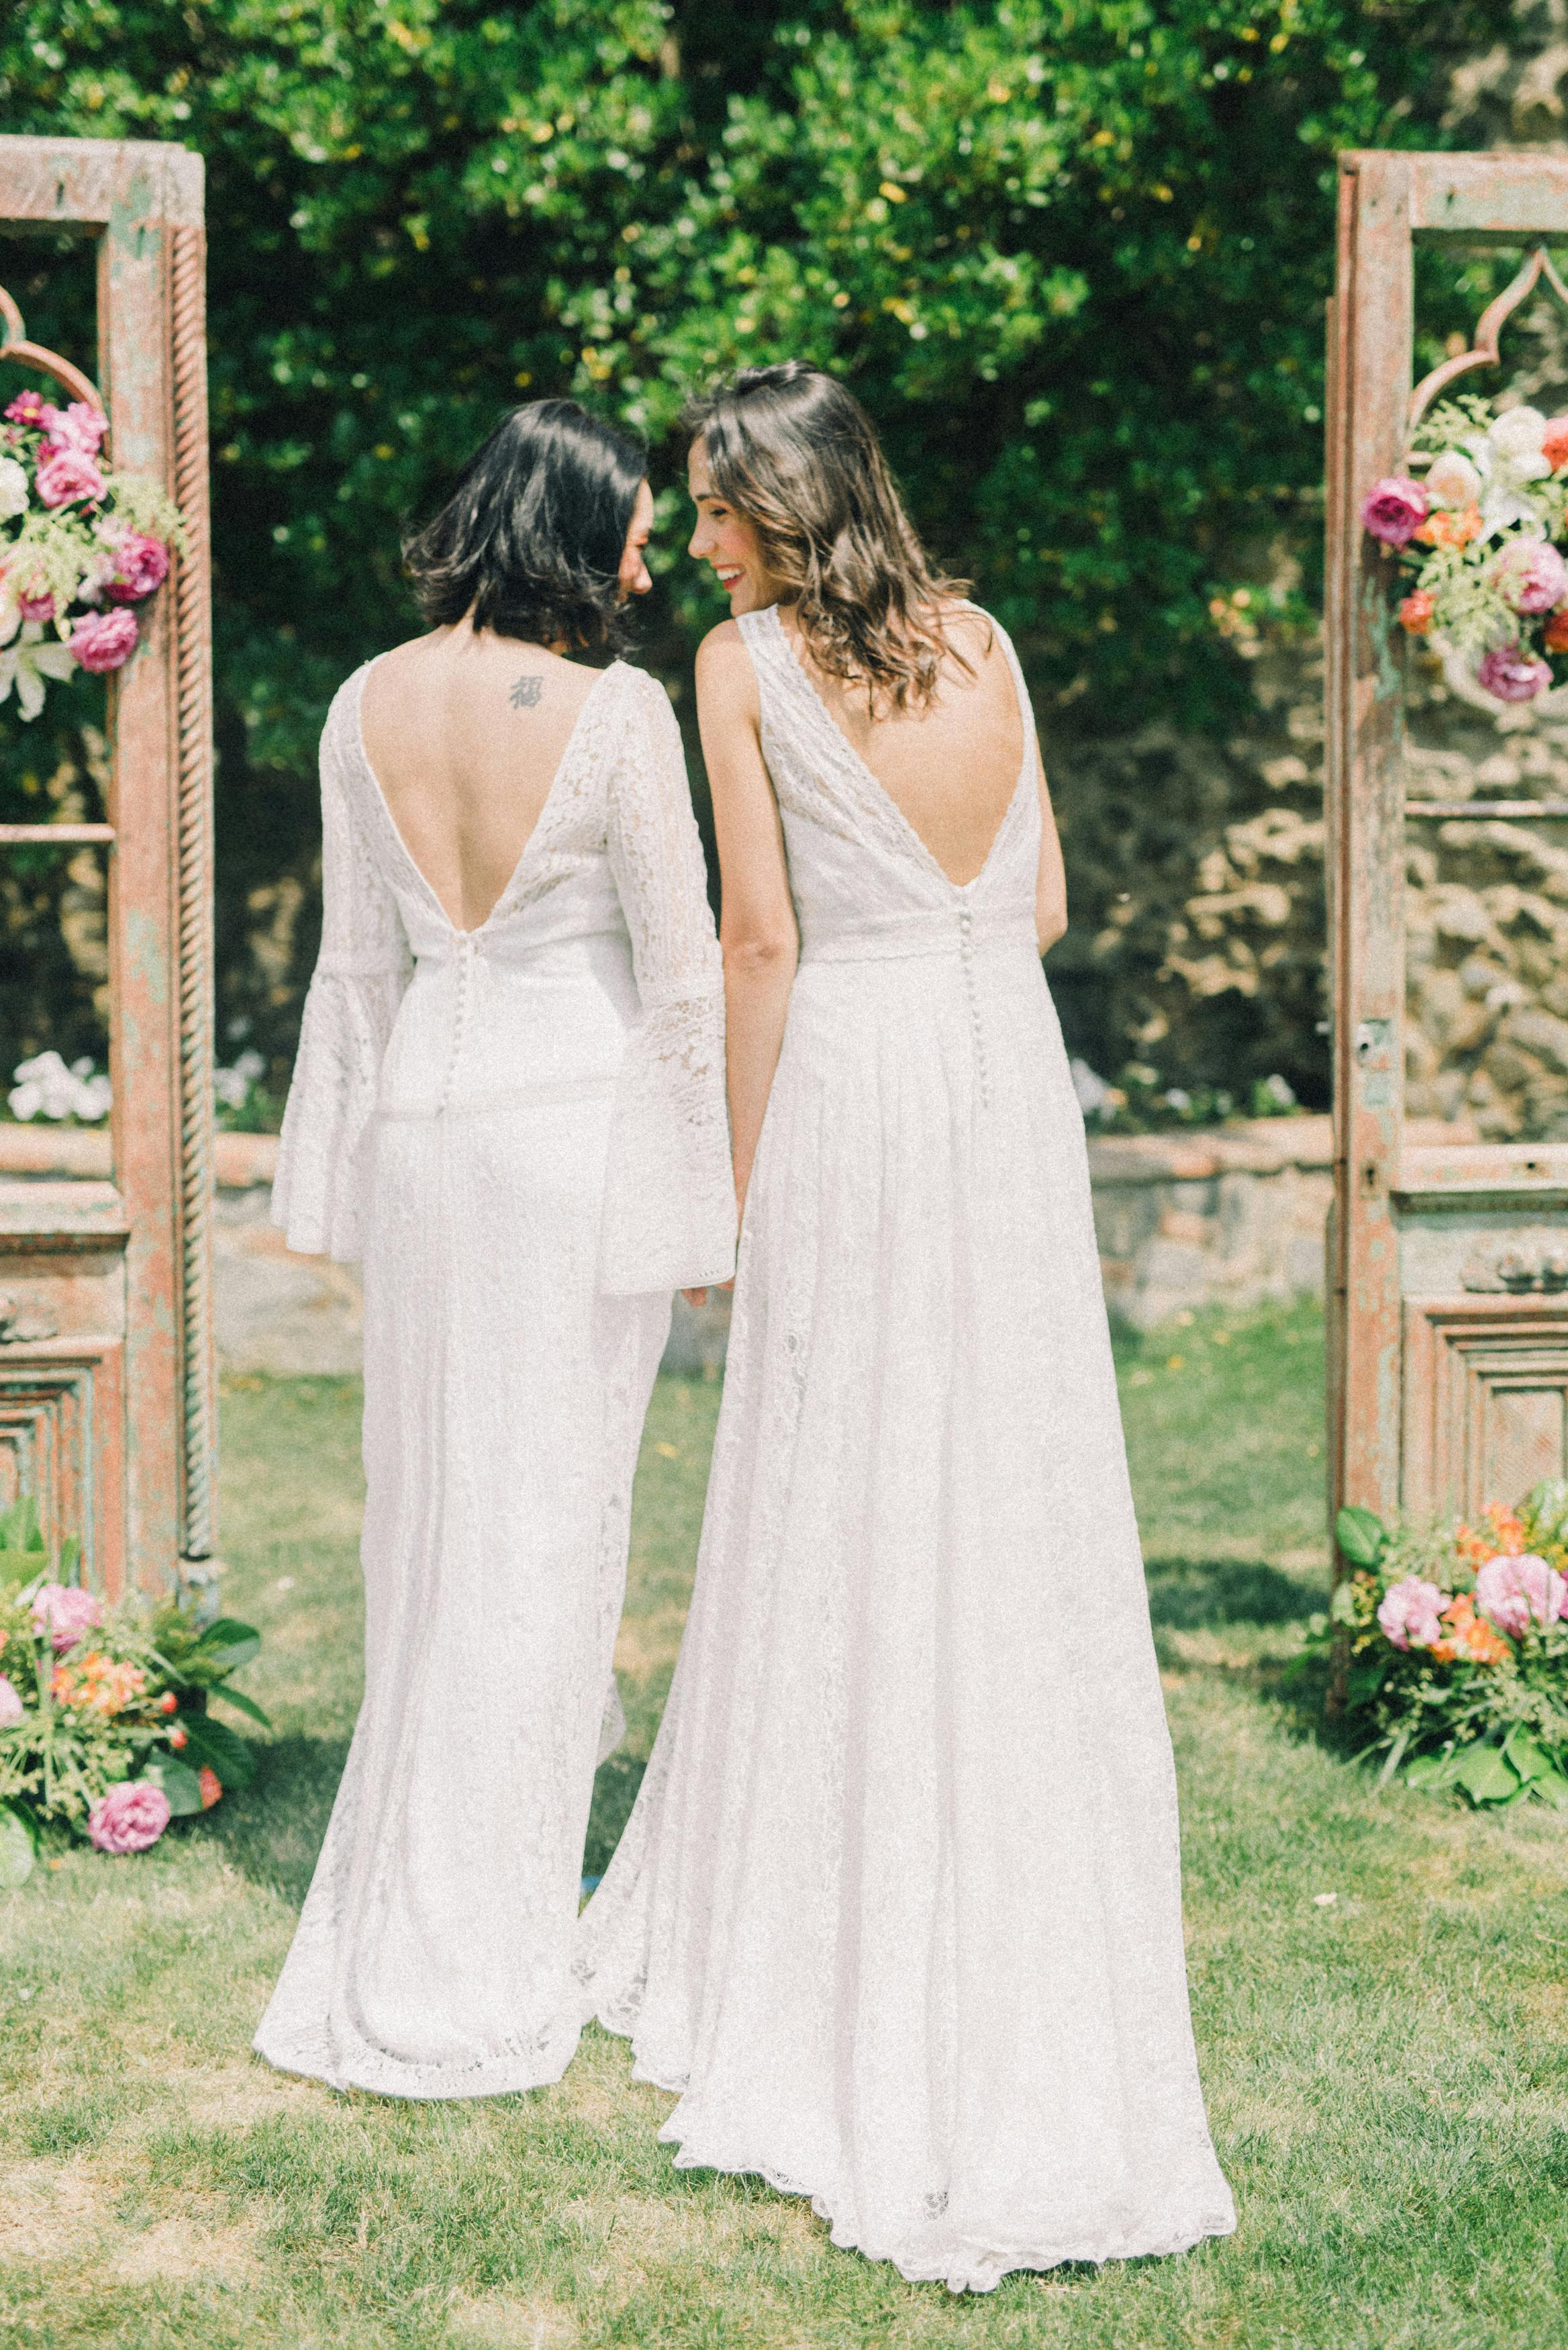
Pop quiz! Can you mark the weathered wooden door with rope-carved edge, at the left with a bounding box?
[0,139,214,1591]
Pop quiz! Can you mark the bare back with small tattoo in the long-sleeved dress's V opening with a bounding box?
[360,623,599,931]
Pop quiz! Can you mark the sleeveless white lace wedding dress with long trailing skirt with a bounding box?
[579,611,1234,2292]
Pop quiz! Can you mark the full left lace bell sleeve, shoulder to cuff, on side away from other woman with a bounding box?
[273,696,409,1262]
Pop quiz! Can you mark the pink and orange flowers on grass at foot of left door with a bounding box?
[0,1499,271,1887]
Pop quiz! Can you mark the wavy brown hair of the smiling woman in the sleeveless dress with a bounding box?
[684,360,971,712]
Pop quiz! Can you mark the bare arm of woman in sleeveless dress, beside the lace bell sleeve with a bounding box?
[696,620,799,1211]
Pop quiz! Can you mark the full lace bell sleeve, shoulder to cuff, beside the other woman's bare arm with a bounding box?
[599,670,736,1297]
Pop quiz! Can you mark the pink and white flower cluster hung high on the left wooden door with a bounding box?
[0,393,186,719]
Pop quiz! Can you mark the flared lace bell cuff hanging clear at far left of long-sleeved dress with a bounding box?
[273,959,404,1264]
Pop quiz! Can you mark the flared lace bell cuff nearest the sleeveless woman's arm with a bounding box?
[599,978,736,1297]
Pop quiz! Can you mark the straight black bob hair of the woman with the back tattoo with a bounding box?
[402,399,646,651]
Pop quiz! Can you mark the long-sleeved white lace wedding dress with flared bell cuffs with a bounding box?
[256,663,734,2096]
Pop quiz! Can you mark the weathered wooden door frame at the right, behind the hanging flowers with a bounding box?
[1326,153,1568,1542]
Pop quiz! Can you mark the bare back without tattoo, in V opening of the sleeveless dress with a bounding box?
[778,606,1022,888]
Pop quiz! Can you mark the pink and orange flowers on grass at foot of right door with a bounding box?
[1307,1478,1568,1807]
